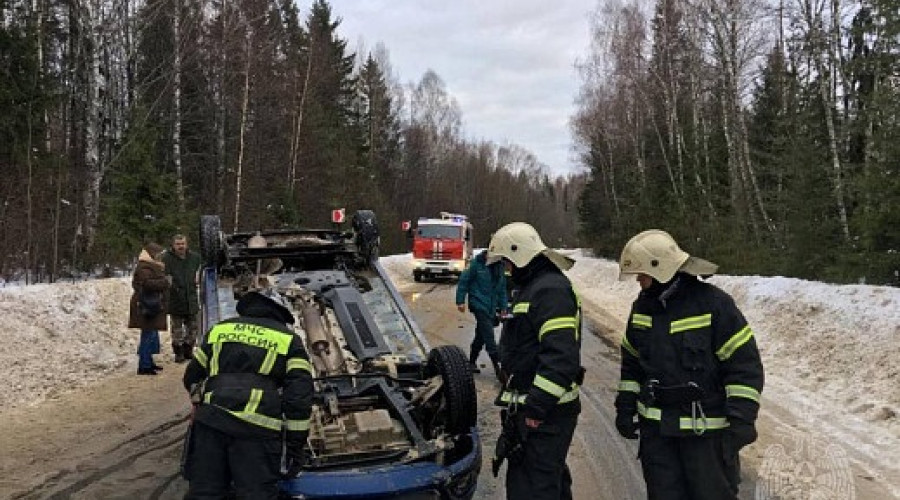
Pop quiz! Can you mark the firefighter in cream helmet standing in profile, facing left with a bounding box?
[488,222,584,500]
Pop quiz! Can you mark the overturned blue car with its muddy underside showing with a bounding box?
[200,211,481,499]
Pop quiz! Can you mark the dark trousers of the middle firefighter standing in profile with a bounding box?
[506,413,578,500]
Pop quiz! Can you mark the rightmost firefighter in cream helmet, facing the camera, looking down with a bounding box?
[616,230,763,500]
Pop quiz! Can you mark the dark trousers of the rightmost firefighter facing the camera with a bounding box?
[639,425,741,500]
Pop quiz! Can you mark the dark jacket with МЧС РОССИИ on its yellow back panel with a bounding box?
[184,316,313,446]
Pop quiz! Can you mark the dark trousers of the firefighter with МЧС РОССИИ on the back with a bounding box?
[184,422,281,500]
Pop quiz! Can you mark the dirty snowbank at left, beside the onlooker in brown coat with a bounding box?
[0,278,138,410]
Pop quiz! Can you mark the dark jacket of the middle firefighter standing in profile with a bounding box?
[497,256,584,420]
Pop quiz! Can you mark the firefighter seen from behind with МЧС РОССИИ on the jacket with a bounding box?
[184,289,313,499]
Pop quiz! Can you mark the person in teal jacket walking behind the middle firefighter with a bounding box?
[456,250,507,382]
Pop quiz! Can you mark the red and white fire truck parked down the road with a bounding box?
[413,212,472,281]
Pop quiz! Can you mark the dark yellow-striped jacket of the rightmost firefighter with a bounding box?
[616,273,764,436]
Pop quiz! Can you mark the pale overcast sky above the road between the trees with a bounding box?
[330,0,596,174]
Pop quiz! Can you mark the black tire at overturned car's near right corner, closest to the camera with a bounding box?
[428,345,477,434]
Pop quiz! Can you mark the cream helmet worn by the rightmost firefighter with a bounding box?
[619,229,719,283]
